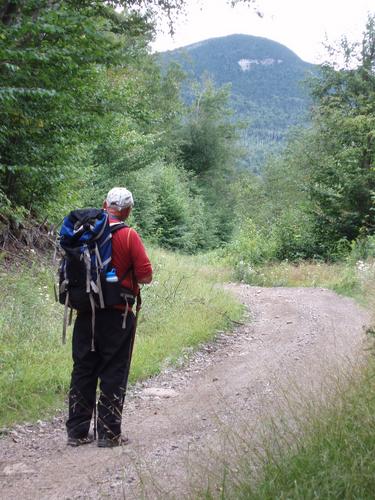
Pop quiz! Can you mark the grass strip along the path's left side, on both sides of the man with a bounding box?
[0,250,242,427]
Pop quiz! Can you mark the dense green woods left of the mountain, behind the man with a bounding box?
[0,2,238,252]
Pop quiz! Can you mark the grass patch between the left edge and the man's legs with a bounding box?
[0,264,70,425]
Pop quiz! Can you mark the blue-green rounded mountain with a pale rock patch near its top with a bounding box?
[161,35,317,170]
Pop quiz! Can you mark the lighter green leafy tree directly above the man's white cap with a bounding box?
[89,58,187,204]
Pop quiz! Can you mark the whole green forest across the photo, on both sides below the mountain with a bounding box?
[0,1,375,263]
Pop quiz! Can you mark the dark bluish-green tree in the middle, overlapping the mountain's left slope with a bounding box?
[175,79,242,245]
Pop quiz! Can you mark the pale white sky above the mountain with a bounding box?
[153,0,375,63]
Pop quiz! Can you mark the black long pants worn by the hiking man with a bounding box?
[66,309,134,439]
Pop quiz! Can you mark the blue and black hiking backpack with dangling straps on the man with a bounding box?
[58,208,134,350]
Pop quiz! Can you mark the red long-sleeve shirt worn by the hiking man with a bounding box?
[110,217,152,295]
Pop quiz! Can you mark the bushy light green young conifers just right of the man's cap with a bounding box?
[124,162,223,253]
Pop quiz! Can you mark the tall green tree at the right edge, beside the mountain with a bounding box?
[307,16,375,255]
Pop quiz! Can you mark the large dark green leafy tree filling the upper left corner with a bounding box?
[0,0,151,212]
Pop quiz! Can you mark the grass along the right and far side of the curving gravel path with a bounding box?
[210,259,375,500]
